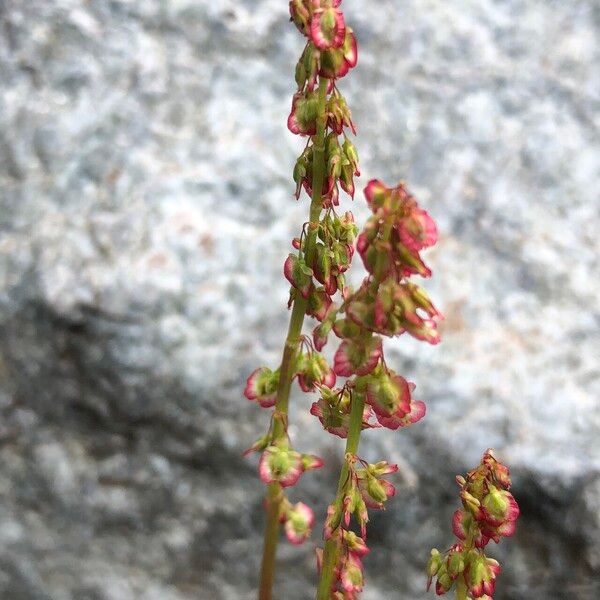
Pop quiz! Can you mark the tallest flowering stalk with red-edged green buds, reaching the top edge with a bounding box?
[244,0,359,600]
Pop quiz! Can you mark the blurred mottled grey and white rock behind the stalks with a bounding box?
[0,0,600,600]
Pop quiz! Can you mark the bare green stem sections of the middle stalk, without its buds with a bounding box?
[317,394,365,600]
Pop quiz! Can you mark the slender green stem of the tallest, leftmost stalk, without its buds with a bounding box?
[258,77,329,600]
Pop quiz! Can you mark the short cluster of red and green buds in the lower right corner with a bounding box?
[427,450,519,600]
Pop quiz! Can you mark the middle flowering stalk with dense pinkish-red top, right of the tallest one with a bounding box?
[311,180,441,600]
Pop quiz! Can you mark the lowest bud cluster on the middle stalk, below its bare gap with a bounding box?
[317,454,398,600]
